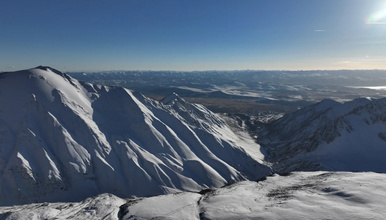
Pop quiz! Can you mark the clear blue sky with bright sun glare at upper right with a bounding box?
[0,0,386,71]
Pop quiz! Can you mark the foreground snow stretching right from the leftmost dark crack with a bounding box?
[121,172,386,219]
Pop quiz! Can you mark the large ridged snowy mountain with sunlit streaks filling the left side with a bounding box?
[0,66,271,205]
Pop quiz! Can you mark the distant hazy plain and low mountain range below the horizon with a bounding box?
[68,70,386,115]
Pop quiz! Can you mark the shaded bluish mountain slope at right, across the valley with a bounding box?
[259,98,386,172]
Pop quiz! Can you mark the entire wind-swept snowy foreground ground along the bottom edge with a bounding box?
[0,172,386,219]
